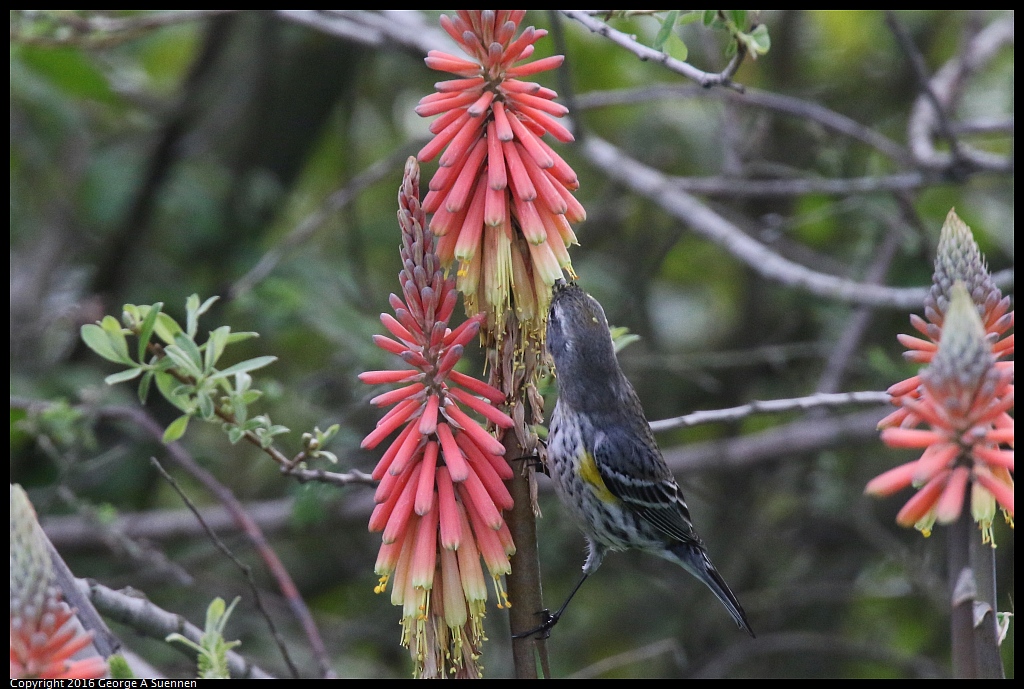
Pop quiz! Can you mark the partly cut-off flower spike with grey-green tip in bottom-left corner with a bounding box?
[10,485,106,680]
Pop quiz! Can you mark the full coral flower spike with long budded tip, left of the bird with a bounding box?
[359,158,515,677]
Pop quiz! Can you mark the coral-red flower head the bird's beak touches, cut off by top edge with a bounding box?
[416,10,586,337]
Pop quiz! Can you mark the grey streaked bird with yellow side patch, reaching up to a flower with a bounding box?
[521,284,754,636]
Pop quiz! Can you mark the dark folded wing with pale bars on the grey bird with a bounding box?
[594,421,700,544]
